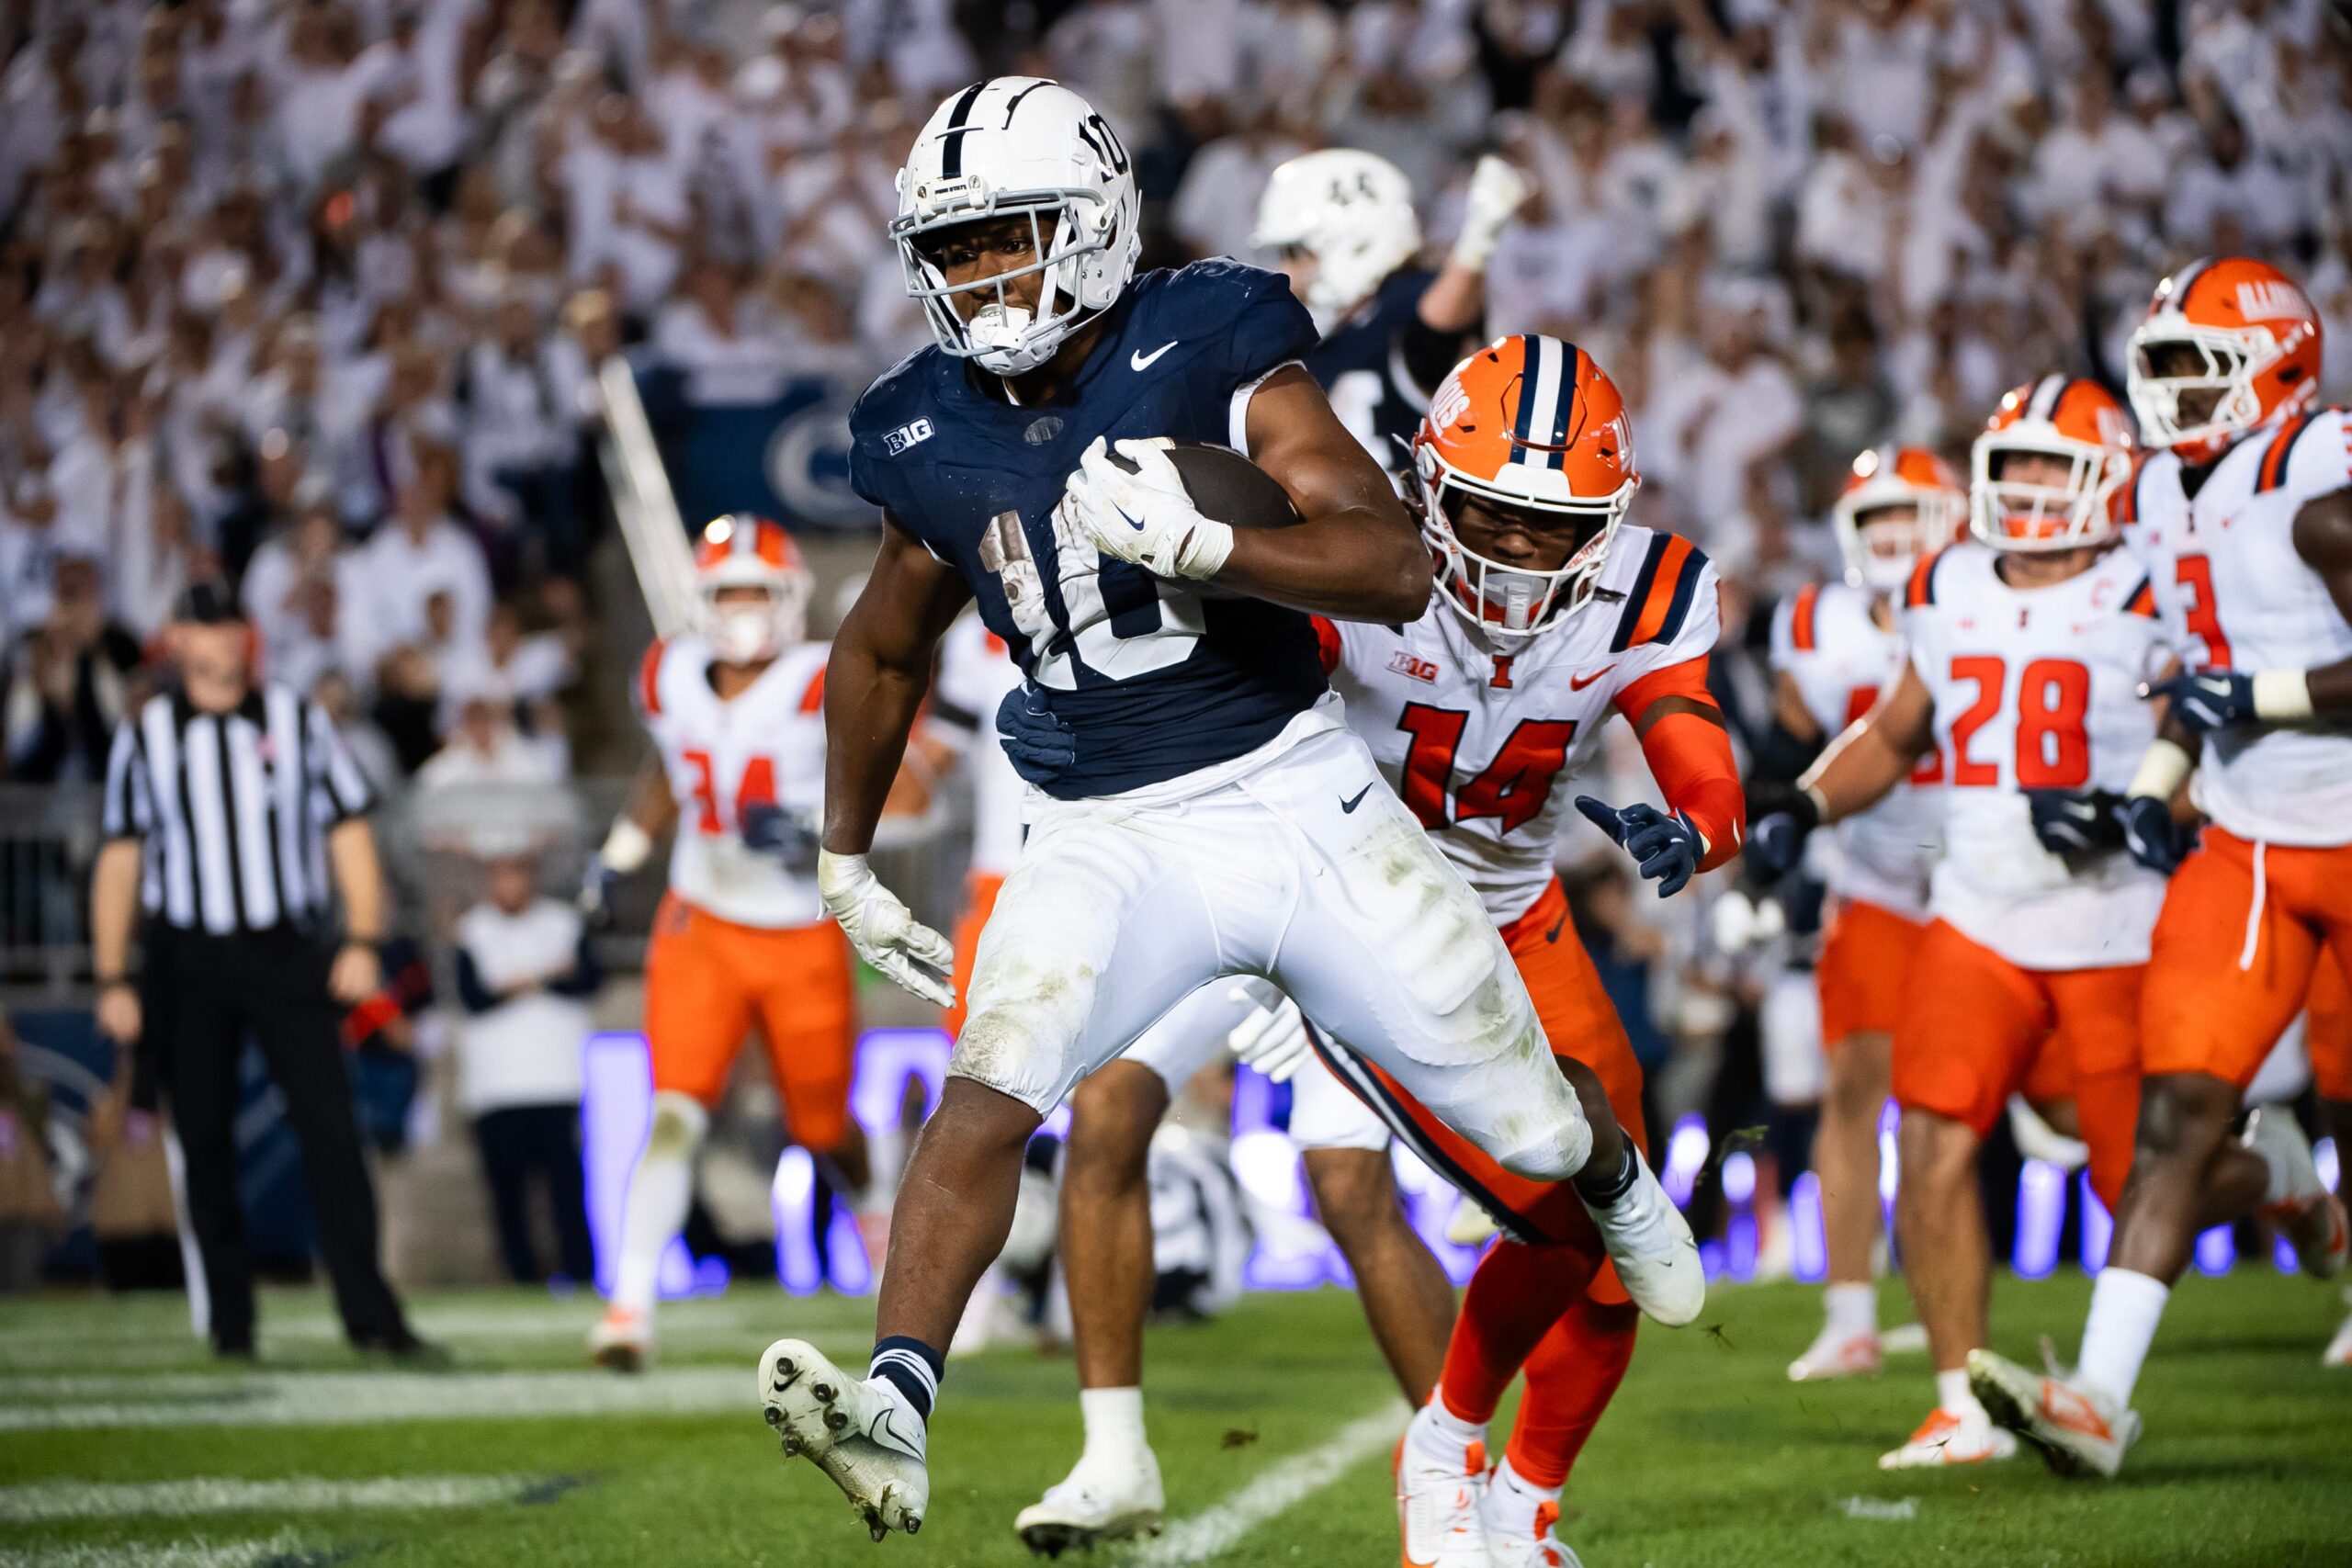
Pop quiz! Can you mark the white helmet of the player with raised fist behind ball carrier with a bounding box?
[1249,148,1420,332]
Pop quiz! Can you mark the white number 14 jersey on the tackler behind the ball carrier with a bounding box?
[1315,526,1722,926]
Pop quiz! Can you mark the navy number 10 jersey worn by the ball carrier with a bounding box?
[849,261,1324,799]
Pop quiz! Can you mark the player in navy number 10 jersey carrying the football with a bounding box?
[760,77,1705,1540]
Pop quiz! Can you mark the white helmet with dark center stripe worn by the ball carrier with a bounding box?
[889,75,1143,376]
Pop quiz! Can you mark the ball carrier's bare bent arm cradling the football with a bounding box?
[1214,365,1430,621]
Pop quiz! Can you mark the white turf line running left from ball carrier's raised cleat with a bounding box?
[0,1361,760,1432]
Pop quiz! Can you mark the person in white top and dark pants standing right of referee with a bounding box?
[457,853,600,1286]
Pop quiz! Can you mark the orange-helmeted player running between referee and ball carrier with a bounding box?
[588,514,865,1371]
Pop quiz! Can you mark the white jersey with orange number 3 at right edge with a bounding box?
[2126,409,2352,844]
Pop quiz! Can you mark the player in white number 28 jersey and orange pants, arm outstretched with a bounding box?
[1750,376,2166,1470]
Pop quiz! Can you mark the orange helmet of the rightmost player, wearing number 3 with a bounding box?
[2126,256,2319,463]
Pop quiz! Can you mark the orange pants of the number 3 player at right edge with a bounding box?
[2143,825,2352,1098]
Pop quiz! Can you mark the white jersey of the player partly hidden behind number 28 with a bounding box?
[1771,583,1943,919]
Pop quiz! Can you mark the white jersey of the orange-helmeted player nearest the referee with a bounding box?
[638,637,826,929]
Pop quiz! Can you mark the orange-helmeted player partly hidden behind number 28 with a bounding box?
[1759,446,1969,1382]
